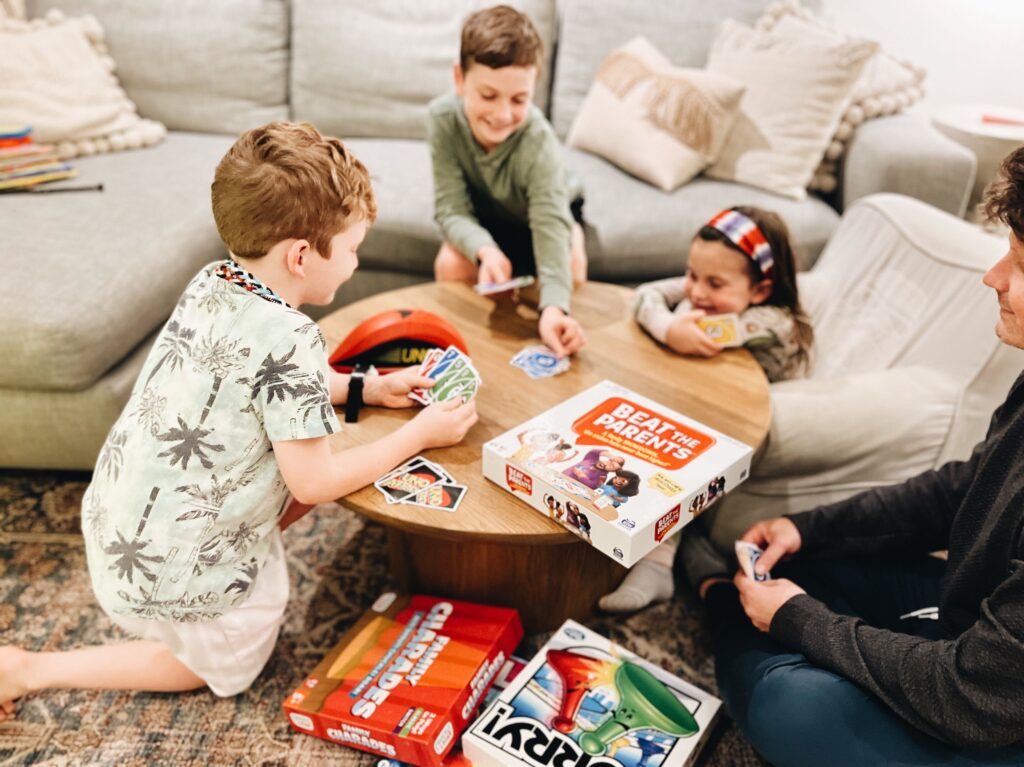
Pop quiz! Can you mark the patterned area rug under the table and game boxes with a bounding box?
[0,471,765,767]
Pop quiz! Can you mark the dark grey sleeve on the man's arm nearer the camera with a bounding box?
[770,559,1024,748]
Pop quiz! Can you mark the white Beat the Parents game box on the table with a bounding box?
[483,381,753,567]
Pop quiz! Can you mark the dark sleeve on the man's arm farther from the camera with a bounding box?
[790,442,984,556]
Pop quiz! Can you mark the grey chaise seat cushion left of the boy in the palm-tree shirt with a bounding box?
[0,132,233,390]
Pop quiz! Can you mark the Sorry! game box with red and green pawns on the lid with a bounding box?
[462,621,722,767]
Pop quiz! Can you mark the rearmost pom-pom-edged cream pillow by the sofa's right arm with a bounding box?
[757,0,925,193]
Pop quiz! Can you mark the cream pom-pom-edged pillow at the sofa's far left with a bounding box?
[0,11,167,158]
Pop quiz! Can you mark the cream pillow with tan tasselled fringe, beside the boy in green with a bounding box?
[567,37,743,191]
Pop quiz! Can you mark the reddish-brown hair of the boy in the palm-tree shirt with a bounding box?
[212,122,377,258]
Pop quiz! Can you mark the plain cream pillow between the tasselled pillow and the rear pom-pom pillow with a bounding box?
[706,20,878,200]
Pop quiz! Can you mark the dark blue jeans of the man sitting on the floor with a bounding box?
[707,556,1024,767]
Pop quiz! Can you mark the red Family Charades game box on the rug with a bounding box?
[284,593,522,767]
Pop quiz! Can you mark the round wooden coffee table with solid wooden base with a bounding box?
[319,283,769,632]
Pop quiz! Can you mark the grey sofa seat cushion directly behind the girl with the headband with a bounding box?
[565,148,839,282]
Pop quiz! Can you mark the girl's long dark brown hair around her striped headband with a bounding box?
[697,205,814,370]
